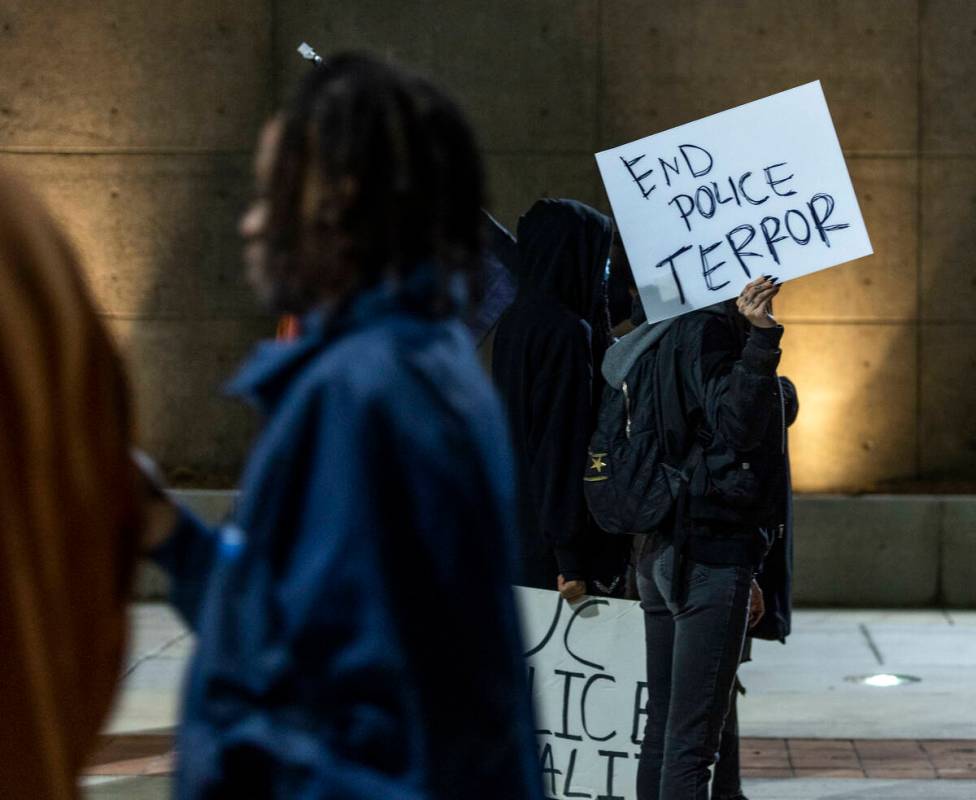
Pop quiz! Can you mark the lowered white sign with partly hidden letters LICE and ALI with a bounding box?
[515,587,647,800]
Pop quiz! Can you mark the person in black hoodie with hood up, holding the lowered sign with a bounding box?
[492,199,629,599]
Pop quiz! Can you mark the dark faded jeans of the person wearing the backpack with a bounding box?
[637,544,752,800]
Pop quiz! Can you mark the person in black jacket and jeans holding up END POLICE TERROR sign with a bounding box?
[603,256,796,800]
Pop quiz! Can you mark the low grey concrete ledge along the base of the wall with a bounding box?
[136,490,976,608]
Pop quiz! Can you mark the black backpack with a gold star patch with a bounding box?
[583,334,702,534]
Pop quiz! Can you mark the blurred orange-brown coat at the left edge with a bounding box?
[0,169,139,800]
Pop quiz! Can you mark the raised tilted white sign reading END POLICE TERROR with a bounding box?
[596,81,873,322]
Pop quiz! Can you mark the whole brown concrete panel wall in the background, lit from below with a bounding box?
[0,0,976,491]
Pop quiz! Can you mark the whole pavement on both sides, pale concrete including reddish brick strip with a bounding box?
[85,604,976,800]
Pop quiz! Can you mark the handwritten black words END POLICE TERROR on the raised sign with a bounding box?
[620,144,850,304]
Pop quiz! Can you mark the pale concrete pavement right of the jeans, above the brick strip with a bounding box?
[739,611,976,736]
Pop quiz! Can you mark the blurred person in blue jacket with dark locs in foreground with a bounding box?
[139,54,541,800]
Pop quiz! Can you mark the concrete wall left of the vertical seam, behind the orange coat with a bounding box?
[0,0,273,481]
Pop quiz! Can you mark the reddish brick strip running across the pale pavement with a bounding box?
[87,733,976,780]
